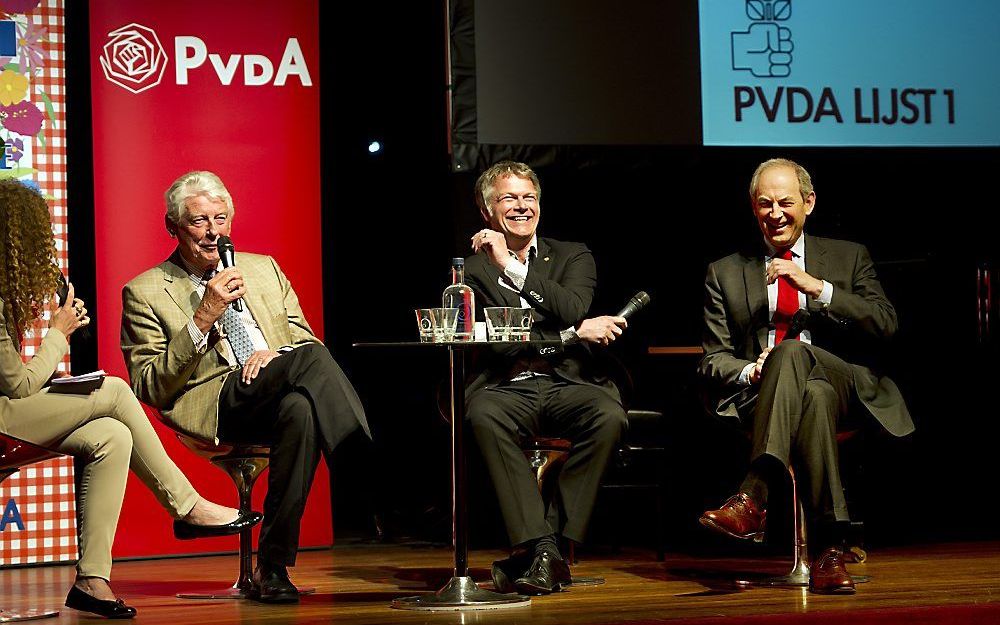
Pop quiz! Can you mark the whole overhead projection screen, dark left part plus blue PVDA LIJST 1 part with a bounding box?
[451,0,1000,147]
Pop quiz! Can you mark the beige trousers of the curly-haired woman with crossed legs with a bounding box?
[0,377,199,579]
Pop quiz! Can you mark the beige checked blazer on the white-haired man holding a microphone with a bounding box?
[121,251,320,442]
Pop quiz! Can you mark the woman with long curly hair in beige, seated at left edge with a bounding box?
[0,179,261,618]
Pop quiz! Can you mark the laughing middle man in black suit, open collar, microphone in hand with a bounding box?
[465,161,627,594]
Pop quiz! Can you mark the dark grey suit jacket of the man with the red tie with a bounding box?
[699,235,913,436]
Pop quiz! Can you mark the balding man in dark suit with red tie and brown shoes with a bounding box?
[699,159,913,593]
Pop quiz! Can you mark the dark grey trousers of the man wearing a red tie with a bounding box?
[744,340,867,521]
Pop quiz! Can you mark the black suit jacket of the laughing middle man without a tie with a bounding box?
[465,237,621,401]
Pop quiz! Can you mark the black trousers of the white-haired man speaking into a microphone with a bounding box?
[219,344,371,566]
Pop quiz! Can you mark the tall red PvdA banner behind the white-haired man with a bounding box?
[84,0,324,557]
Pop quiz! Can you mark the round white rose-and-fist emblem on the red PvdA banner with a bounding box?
[101,23,167,93]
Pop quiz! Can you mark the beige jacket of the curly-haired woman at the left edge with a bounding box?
[0,300,69,424]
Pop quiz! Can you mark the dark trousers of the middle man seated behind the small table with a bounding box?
[466,376,626,545]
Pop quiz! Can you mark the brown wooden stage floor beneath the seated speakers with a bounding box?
[0,543,1000,625]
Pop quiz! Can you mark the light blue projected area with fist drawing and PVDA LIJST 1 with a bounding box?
[699,0,1000,146]
